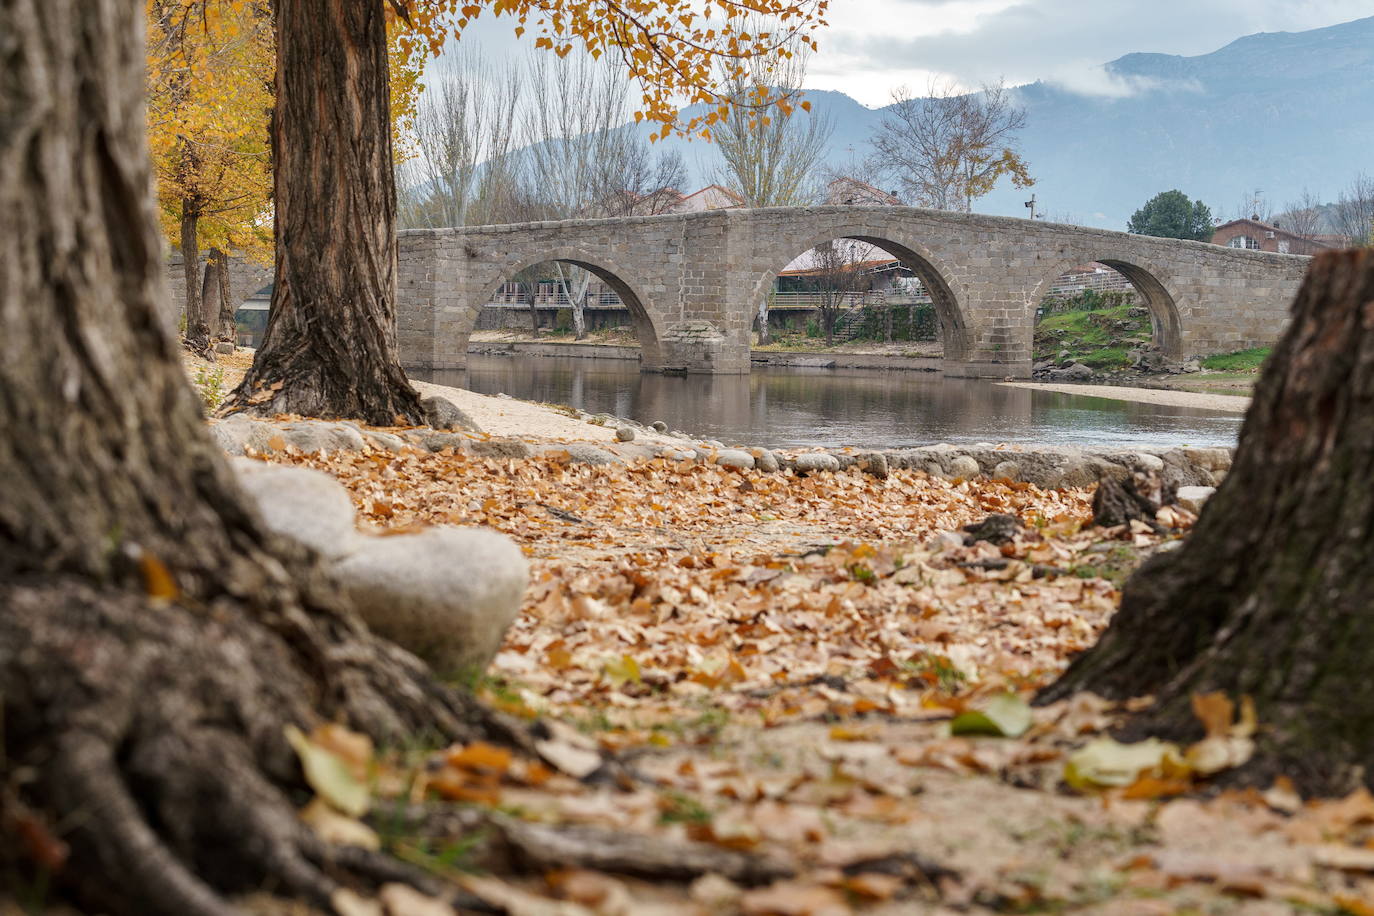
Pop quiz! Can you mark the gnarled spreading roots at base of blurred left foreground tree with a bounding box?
[0,578,534,916]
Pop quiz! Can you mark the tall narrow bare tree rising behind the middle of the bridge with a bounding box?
[712,22,834,207]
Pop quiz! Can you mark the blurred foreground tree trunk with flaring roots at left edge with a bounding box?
[0,0,505,916]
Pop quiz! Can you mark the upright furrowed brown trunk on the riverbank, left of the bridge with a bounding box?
[224,0,425,424]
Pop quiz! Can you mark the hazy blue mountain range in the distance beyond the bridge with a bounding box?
[645,16,1374,229]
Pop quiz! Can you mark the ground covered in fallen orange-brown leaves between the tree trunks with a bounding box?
[255,439,1374,916]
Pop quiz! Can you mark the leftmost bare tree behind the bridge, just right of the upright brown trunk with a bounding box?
[397,49,526,228]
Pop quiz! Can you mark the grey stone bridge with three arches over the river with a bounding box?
[211,206,1308,378]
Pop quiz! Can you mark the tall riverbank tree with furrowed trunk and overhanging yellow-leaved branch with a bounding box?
[223,0,829,423]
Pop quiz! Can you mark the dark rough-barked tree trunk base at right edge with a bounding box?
[1043,251,1374,792]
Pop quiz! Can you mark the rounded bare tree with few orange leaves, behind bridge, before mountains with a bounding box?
[870,80,1035,211]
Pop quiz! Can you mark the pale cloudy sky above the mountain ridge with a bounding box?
[450,0,1374,106]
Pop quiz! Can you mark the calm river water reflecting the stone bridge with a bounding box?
[416,354,1241,448]
